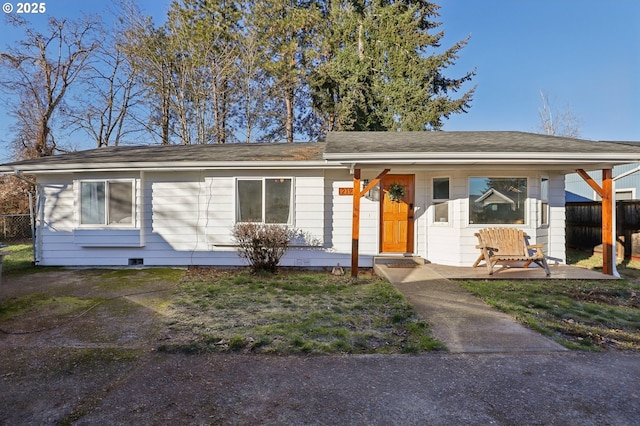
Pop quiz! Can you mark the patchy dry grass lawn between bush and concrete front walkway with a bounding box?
[161,268,443,353]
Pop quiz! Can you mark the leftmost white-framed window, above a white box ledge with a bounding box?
[80,180,133,225]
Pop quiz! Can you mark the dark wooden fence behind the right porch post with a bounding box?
[566,200,640,257]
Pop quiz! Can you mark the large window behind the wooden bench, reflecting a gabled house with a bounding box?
[469,177,527,224]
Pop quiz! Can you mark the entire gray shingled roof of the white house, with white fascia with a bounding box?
[0,131,640,173]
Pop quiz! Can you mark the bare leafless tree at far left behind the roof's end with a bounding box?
[0,15,99,157]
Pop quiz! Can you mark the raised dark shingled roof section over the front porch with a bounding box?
[325,131,640,154]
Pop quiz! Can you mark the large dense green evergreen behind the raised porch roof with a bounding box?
[311,0,475,131]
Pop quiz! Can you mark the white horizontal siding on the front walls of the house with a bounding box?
[30,167,565,267]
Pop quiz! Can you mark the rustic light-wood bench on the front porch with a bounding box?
[473,228,551,276]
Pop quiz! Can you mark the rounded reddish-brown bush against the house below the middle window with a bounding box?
[232,222,295,273]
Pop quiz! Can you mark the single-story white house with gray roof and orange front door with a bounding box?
[0,132,640,267]
